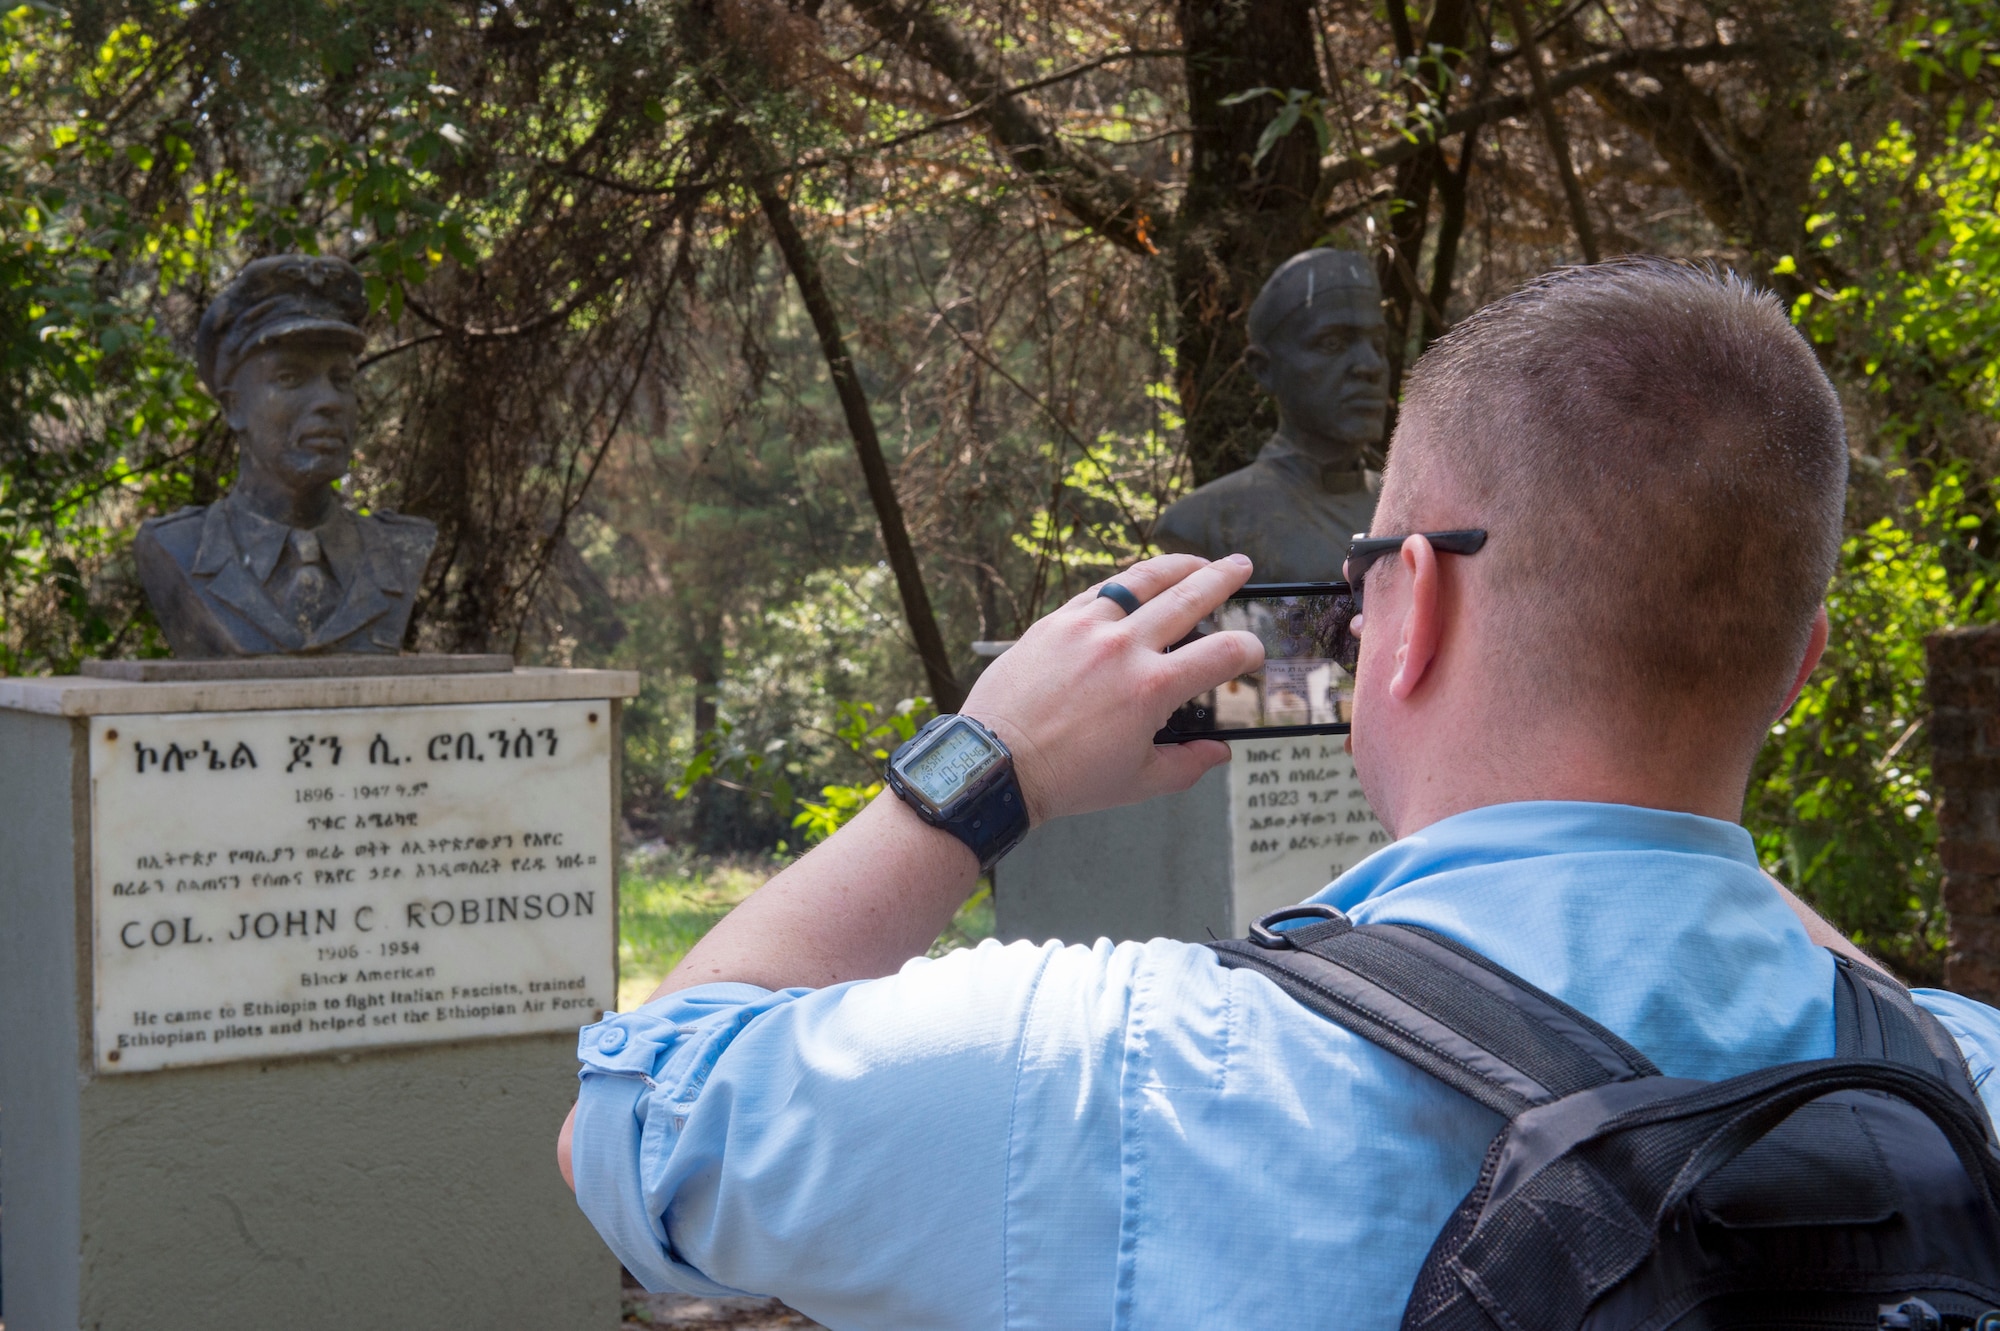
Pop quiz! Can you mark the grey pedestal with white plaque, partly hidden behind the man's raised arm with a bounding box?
[994,735,1390,943]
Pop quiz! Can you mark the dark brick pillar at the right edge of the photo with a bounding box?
[1924,628,2000,1003]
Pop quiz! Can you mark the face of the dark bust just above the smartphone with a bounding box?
[1248,288,1388,460]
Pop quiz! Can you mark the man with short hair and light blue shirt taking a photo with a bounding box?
[558,260,2000,1327]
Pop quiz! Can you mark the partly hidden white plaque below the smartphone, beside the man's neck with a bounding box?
[1228,735,1390,933]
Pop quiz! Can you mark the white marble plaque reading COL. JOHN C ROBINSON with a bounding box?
[90,701,616,1073]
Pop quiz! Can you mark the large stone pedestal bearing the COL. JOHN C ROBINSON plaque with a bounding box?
[0,669,638,1331]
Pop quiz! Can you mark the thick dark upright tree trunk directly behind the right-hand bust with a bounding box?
[1170,0,1322,484]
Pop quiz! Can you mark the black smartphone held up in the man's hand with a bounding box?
[1152,582,1360,743]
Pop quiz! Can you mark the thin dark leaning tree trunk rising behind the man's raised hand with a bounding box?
[756,180,966,711]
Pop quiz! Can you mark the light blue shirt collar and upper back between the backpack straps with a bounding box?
[1312,801,1834,1079]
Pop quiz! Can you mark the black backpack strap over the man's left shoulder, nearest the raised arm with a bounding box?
[1210,905,1660,1119]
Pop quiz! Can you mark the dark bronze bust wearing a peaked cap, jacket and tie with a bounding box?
[132,254,438,658]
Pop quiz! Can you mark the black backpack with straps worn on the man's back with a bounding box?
[1210,905,2000,1331]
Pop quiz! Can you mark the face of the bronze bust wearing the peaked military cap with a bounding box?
[224,340,358,494]
